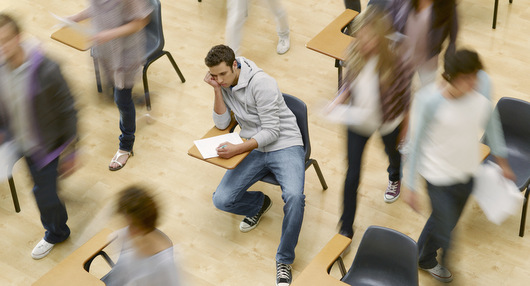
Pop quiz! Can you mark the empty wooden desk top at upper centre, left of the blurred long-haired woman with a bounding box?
[306,9,359,61]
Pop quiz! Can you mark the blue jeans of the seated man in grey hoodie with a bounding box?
[213,146,305,264]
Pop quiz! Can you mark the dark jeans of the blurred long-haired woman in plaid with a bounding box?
[340,127,401,236]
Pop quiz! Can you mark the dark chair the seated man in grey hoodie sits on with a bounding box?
[231,93,328,190]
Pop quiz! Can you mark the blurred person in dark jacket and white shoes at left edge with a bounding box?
[0,13,77,259]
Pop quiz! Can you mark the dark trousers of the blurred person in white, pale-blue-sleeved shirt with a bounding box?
[418,178,473,269]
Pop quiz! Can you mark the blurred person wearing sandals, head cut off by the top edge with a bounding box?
[69,0,153,171]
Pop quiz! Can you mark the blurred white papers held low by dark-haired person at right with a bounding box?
[473,162,524,225]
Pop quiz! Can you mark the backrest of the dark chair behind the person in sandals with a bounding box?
[144,0,165,58]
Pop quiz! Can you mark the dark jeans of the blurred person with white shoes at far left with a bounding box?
[26,157,70,244]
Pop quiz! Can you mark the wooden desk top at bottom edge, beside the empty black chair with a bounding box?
[291,234,351,286]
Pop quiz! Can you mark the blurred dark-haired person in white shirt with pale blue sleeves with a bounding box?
[405,50,515,282]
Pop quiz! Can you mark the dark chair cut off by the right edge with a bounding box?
[484,97,530,237]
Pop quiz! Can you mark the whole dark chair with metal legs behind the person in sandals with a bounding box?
[91,0,186,111]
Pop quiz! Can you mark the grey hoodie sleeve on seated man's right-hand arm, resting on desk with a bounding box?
[252,76,282,147]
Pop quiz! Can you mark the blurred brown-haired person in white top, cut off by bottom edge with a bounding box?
[101,186,182,286]
